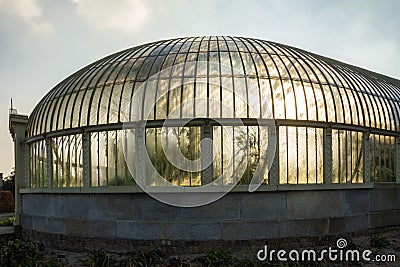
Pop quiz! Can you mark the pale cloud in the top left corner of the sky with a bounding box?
[0,0,53,34]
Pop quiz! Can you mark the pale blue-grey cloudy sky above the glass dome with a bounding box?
[0,0,400,175]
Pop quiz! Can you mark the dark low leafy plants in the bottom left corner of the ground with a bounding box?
[0,239,38,267]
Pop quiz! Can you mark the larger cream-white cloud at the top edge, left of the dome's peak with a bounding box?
[71,0,152,33]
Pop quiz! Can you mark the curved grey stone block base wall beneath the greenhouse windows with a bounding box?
[21,184,400,253]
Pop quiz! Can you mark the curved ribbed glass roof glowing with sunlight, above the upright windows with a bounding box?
[28,36,400,137]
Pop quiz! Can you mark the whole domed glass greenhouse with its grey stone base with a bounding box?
[10,36,400,252]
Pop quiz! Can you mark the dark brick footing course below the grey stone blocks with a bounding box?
[22,226,400,255]
